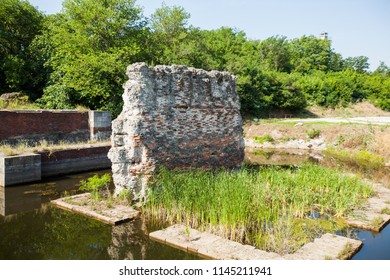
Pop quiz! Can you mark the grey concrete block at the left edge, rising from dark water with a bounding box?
[0,154,41,187]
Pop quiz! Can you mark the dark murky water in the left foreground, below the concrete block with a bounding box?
[0,171,197,260]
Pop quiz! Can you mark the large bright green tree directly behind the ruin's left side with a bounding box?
[40,0,148,116]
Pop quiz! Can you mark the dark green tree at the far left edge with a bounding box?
[0,0,44,98]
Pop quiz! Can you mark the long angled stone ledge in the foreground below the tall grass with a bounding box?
[149,225,362,260]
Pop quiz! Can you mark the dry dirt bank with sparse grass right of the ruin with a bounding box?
[243,102,390,162]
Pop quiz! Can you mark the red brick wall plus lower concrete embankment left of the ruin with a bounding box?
[0,110,111,186]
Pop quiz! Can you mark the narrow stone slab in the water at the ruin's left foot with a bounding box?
[51,193,140,225]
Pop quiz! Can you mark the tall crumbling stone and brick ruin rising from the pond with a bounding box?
[108,63,244,200]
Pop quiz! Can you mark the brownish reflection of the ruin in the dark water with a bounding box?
[107,219,148,260]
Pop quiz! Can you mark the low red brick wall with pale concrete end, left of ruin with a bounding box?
[0,110,111,144]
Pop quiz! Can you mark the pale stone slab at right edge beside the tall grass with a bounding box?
[346,184,390,232]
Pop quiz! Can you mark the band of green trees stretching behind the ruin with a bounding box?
[0,0,390,115]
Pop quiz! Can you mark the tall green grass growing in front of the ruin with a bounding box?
[144,165,373,254]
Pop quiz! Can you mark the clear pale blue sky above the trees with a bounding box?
[29,0,390,70]
